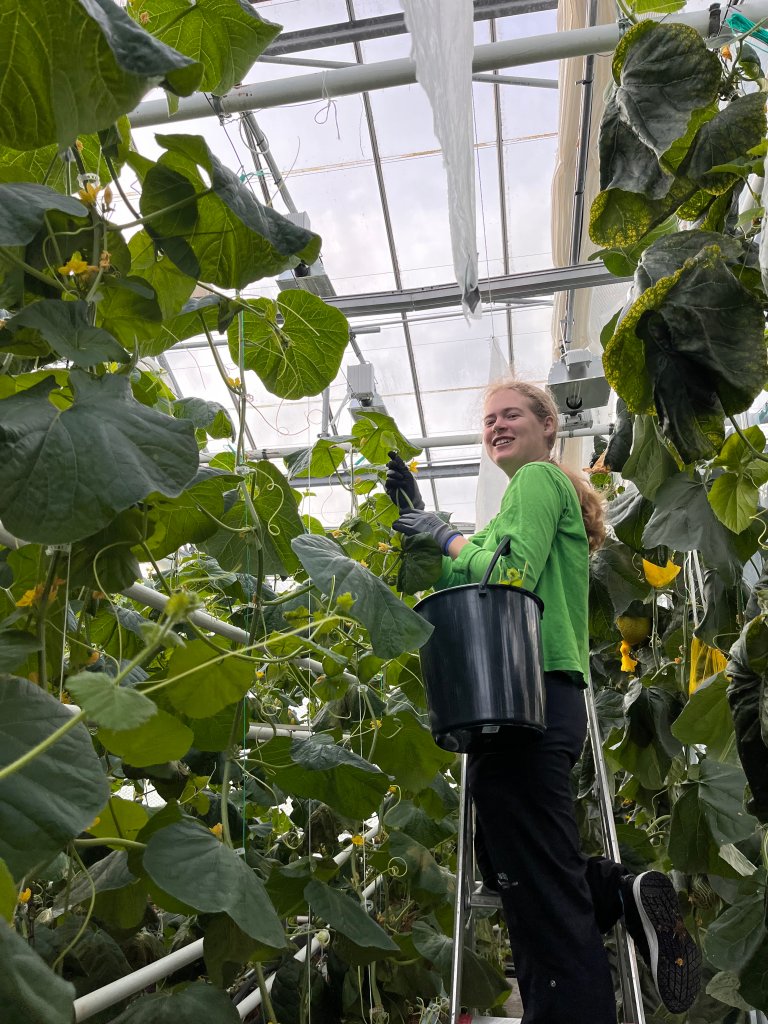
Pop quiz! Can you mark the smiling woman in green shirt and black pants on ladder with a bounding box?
[386,381,701,1024]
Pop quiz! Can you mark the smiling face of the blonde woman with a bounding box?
[482,388,557,477]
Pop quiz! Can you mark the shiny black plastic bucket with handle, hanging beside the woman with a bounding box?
[415,539,545,754]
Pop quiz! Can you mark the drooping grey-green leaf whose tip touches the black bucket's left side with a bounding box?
[292,535,432,658]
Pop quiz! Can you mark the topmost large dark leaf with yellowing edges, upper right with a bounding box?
[613,22,721,159]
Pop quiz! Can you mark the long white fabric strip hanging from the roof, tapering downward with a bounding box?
[401,0,480,315]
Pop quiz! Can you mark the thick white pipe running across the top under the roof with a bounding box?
[128,0,768,128]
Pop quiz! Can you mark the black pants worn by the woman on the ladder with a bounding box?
[469,673,628,1024]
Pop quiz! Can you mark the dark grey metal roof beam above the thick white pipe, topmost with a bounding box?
[264,0,557,57]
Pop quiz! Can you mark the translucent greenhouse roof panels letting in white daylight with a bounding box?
[124,0,716,523]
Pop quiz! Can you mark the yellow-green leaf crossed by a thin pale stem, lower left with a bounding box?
[163,640,255,718]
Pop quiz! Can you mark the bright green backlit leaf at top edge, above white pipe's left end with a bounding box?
[130,0,281,96]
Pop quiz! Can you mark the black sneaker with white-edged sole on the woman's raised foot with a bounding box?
[622,871,701,1014]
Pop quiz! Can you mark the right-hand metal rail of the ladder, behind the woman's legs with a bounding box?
[584,678,645,1024]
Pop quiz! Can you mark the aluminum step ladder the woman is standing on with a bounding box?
[450,681,645,1024]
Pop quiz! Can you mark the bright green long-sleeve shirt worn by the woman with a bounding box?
[435,462,589,681]
